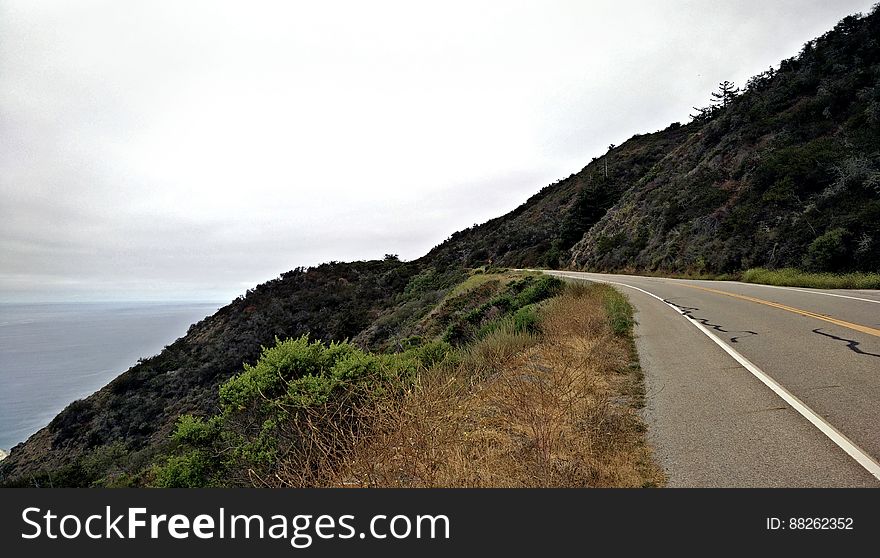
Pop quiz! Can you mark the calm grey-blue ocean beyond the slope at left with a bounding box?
[0,302,222,451]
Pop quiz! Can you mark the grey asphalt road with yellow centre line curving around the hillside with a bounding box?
[547,271,880,487]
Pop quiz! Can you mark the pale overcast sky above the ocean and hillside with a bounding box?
[0,0,873,301]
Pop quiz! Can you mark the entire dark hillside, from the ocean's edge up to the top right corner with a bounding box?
[0,9,880,490]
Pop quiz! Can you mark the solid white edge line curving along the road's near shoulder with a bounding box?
[553,273,880,480]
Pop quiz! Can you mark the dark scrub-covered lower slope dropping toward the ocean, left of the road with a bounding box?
[0,258,434,484]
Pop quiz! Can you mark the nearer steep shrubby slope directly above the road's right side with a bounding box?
[571,10,880,272]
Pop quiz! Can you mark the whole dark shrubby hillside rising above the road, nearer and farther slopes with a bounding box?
[426,9,880,273]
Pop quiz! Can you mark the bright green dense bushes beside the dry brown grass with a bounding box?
[152,336,452,487]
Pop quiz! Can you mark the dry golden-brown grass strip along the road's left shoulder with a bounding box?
[268,286,664,487]
